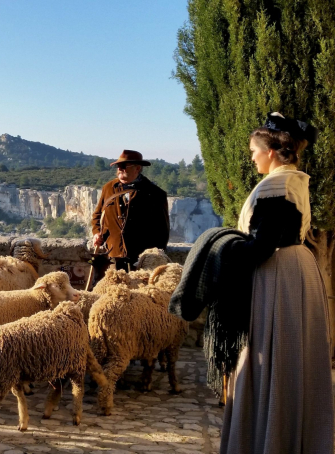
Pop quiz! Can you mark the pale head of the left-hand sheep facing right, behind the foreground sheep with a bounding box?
[33,271,79,308]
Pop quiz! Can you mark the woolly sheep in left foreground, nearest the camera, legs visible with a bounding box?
[0,301,107,431]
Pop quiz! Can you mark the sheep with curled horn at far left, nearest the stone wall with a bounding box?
[0,238,46,291]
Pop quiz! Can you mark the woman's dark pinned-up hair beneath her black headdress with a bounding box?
[250,127,308,164]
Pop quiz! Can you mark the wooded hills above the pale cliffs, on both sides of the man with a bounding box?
[0,134,209,198]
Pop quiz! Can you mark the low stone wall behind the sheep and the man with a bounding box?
[0,236,206,347]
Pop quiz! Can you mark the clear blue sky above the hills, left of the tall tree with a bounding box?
[0,0,200,162]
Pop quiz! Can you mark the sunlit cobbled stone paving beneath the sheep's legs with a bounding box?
[0,348,223,454]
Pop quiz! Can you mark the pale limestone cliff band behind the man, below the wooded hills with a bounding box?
[0,183,222,243]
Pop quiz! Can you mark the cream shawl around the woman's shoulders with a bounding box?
[238,165,311,243]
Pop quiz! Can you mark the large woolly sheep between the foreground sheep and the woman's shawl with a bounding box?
[88,263,188,415]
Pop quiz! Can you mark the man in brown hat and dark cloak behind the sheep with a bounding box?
[92,150,170,270]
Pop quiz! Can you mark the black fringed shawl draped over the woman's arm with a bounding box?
[169,228,251,394]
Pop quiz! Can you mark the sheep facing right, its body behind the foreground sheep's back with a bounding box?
[0,271,79,325]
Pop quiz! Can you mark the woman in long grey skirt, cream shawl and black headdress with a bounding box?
[220,113,333,454]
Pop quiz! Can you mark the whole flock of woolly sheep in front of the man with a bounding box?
[0,239,188,430]
